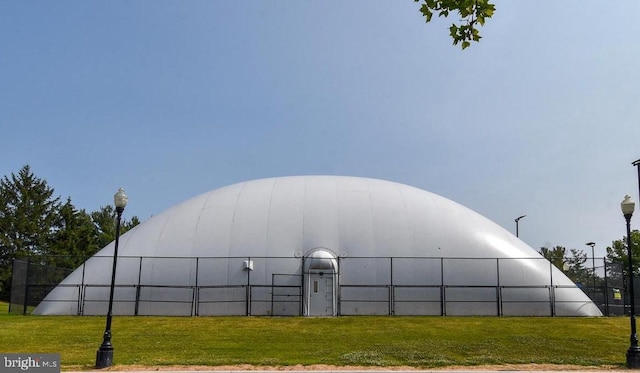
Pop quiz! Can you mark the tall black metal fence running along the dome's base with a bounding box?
[10,257,624,316]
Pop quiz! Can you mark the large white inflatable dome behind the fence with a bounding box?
[34,176,601,316]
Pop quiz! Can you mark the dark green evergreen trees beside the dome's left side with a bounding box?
[0,165,140,301]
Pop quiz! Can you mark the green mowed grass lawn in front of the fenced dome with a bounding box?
[0,304,629,370]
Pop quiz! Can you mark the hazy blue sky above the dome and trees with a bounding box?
[0,0,640,256]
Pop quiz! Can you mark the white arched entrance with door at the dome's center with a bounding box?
[303,248,338,316]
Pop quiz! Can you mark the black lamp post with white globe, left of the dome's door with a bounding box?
[96,188,128,368]
